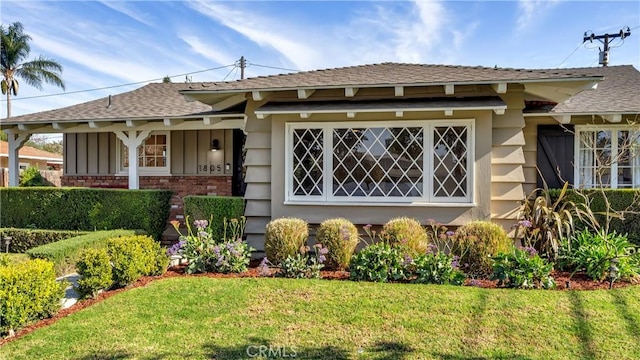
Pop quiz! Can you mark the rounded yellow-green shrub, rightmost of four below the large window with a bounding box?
[453,221,513,276]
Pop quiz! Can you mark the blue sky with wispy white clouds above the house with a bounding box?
[0,0,640,139]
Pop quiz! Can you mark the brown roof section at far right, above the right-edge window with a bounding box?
[553,65,640,113]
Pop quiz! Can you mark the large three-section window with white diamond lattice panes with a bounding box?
[285,120,473,203]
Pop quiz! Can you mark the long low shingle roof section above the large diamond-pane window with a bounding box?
[186,63,597,92]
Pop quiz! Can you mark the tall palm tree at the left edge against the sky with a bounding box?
[0,22,65,118]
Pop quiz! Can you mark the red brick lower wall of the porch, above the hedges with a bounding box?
[62,175,232,220]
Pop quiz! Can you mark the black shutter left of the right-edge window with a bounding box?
[537,125,575,188]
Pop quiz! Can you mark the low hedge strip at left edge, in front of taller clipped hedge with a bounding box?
[0,228,86,253]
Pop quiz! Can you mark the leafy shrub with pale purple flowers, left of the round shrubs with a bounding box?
[168,217,254,274]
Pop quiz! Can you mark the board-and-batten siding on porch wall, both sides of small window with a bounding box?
[63,130,233,176]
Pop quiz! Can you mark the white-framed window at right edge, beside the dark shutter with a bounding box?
[576,126,640,189]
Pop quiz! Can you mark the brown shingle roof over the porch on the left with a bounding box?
[3,83,211,123]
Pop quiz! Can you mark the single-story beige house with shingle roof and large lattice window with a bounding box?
[1,63,640,250]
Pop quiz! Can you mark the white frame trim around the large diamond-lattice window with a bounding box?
[284,119,475,207]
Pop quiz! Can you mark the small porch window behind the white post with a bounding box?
[120,132,169,174]
